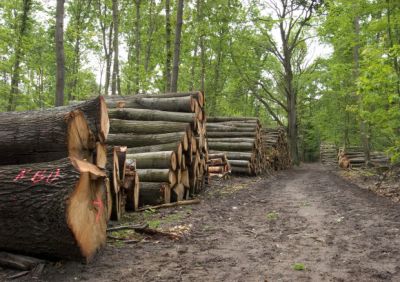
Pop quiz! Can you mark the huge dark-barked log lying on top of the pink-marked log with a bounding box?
[0,111,95,165]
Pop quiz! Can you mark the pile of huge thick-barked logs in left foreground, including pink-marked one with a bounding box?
[0,97,111,261]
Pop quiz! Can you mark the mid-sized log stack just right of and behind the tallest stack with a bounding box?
[207,117,268,175]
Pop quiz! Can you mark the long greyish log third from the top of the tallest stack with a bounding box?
[110,119,190,134]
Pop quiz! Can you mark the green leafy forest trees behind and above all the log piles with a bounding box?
[0,0,400,162]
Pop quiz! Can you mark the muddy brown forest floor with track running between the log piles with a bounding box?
[0,164,400,281]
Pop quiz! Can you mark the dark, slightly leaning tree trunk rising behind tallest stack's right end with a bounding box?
[171,0,183,92]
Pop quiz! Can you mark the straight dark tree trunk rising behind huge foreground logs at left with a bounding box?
[55,0,65,107]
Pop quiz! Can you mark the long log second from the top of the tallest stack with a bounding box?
[108,109,197,123]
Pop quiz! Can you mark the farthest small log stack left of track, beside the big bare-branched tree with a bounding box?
[262,127,292,170]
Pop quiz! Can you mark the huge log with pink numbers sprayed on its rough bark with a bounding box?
[0,158,107,260]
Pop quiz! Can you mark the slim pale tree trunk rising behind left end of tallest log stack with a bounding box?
[111,0,121,95]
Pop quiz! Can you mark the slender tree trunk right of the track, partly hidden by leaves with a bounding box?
[353,16,370,162]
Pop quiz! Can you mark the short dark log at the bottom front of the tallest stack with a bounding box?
[139,182,171,206]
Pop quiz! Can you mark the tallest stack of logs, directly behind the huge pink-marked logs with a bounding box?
[107,92,208,209]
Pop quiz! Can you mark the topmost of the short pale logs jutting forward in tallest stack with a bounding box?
[127,151,177,170]
